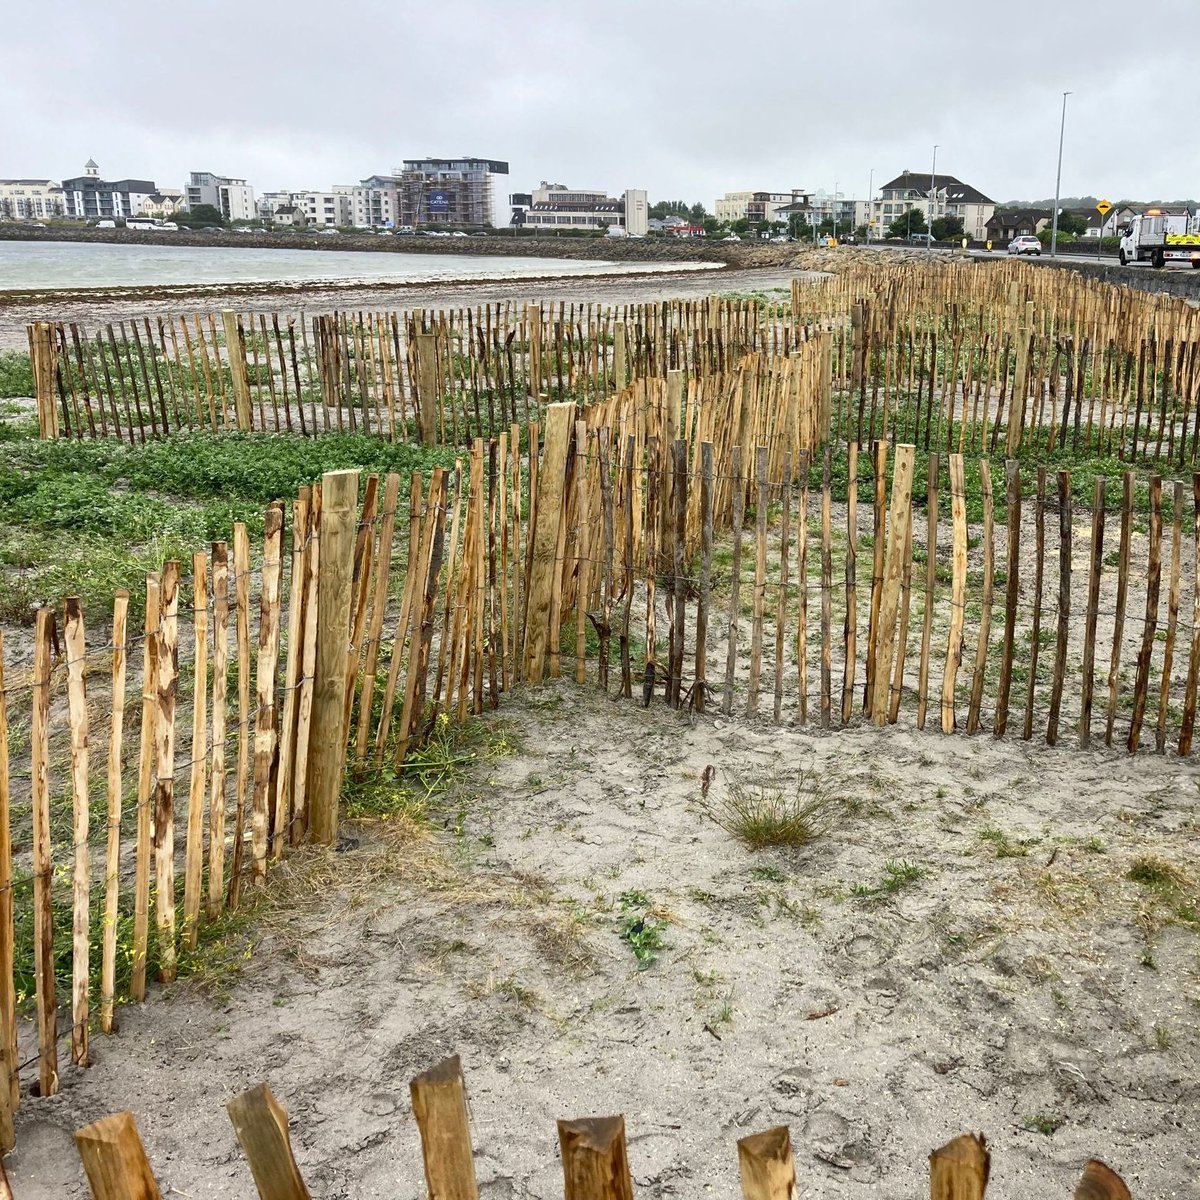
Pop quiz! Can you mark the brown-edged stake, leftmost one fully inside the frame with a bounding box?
[30,608,59,1097]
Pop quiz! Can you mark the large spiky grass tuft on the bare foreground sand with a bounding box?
[703,768,847,850]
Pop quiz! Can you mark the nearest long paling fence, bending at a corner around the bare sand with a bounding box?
[0,400,1200,1145]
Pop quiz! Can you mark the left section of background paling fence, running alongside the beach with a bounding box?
[21,296,808,446]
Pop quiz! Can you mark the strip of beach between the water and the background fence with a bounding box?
[0,266,804,350]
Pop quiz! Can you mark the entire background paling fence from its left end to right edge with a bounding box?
[21,258,1200,469]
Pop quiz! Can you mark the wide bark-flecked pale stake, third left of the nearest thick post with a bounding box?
[251,504,283,884]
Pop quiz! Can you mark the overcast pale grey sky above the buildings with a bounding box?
[0,0,1200,209]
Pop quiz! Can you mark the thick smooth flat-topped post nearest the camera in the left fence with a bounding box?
[298,470,359,846]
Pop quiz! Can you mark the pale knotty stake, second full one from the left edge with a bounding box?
[66,596,91,1067]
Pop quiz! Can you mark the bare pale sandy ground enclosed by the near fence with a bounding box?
[10,683,1200,1200]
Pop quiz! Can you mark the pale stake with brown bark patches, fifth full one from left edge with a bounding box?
[154,559,179,983]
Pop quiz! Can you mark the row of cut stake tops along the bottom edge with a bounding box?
[49,1055,1132,1200]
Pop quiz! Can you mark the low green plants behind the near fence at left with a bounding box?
[0,431,454,624]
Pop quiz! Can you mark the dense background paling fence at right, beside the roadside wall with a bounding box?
[792,259,1200,467]
